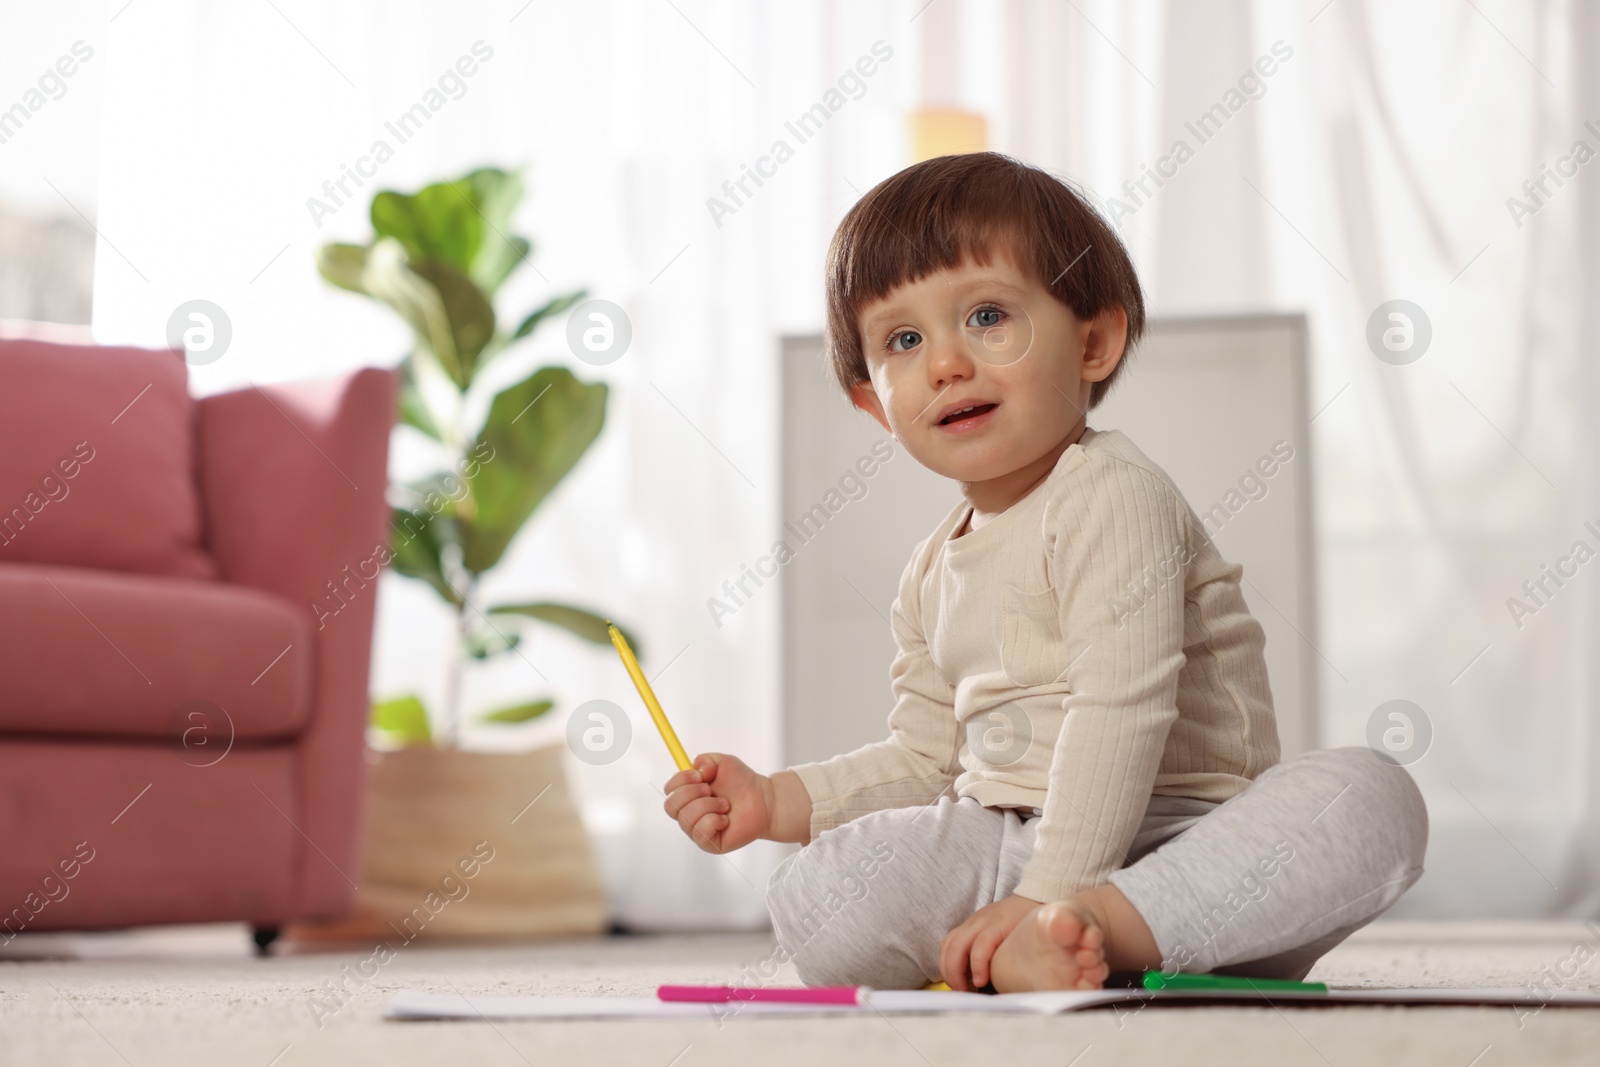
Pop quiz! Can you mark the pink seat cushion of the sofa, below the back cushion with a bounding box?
[0,563,312,739]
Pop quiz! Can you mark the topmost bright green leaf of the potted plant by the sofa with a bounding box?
[371,166,531,293]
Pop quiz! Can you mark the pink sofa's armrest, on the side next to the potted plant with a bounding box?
[198,370,395,917]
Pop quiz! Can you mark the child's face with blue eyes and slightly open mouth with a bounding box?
[851,246,1128,488]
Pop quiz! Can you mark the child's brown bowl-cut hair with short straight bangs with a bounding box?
[826,152,1144,408]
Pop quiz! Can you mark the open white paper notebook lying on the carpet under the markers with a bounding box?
[384,989,1600,1019]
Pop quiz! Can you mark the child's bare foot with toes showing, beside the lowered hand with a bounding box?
[990,897,1110,993]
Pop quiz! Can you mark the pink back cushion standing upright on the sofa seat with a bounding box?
[0,341,216,577]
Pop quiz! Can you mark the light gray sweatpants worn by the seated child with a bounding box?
[766,747,1427,989]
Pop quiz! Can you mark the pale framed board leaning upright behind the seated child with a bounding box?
[779,314,1322,763]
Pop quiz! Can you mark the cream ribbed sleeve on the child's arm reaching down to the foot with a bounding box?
[1016,456,1194,901]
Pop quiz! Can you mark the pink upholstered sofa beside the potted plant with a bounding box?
[0,341,395,958]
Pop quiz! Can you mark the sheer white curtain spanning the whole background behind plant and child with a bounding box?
[94,0,1600,926]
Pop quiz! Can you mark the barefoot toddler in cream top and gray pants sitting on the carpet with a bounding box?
[664,152,1427,992]
